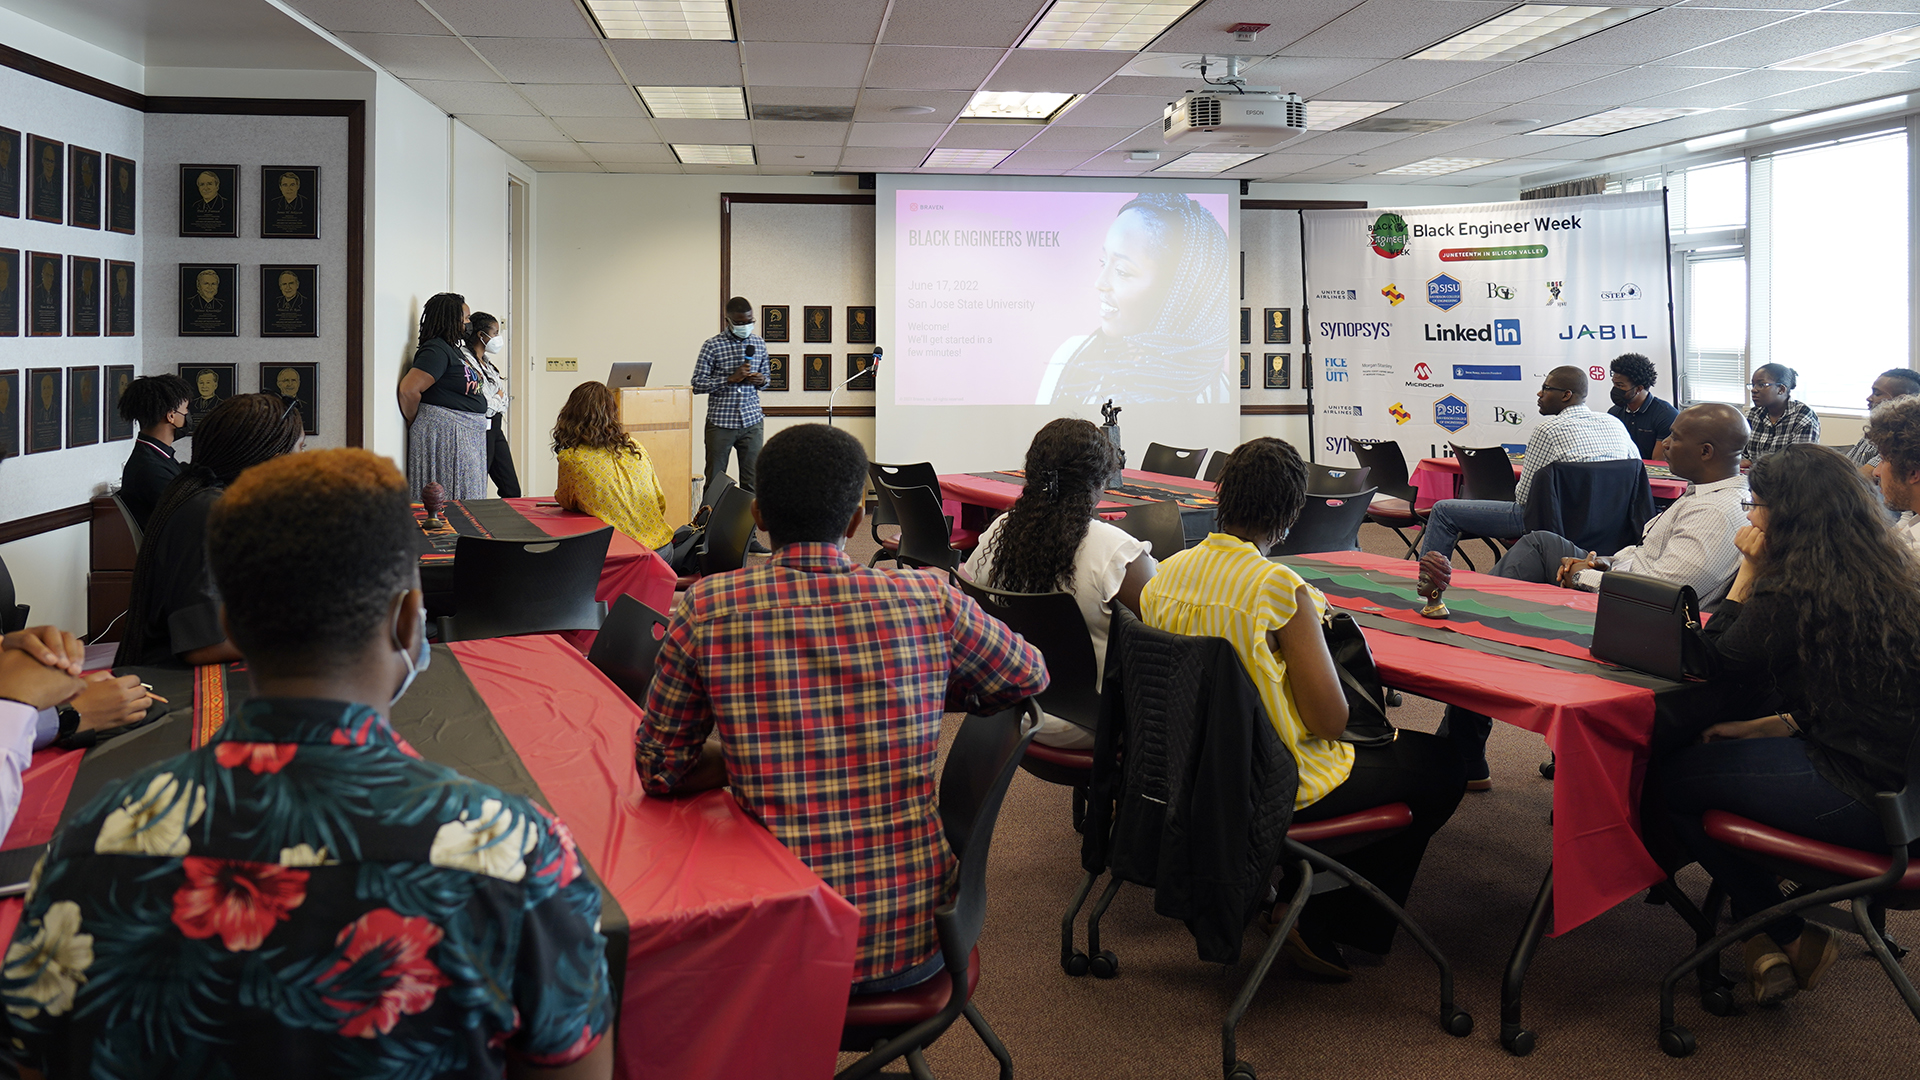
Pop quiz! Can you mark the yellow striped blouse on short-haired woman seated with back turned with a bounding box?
[1140,532,1354,809]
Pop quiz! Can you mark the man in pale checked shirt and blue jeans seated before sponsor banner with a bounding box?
[1421,367,1640,559]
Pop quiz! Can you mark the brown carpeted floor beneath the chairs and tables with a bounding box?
[825,525,1920,1080]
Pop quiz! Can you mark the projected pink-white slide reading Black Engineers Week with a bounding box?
[883,187,1240,405]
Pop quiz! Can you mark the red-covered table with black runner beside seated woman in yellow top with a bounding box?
[413,498,678,653]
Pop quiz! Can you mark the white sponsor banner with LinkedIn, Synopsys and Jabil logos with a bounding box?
[1302,192,1672,463]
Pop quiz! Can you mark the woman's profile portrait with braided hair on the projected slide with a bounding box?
[1035,192,1235,405]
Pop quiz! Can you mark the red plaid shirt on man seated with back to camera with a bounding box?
[637,544,1046,982]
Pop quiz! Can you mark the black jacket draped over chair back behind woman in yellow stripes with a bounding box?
[1081,609,1300,963]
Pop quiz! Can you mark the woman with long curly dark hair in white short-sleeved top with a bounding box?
[966,419,1144,749]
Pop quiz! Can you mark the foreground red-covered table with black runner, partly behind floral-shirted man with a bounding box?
[0,636,860,1080]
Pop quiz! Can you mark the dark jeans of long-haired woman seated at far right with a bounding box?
[1661,738,1887,945]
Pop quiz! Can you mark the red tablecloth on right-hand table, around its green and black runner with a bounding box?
[1311,552,1665,934]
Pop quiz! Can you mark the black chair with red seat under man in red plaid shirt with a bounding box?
[835,701,1041,1080]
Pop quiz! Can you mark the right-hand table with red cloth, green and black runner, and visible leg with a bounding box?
[1275,552,1705,1053]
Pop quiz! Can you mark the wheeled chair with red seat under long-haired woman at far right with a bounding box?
[1661,740,1920,1057]
